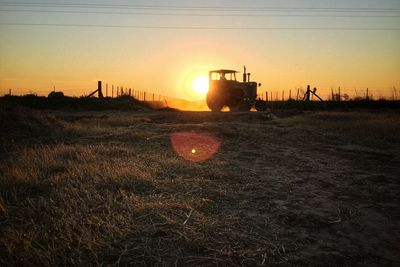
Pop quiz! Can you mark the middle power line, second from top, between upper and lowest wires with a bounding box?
[0,9,400,18]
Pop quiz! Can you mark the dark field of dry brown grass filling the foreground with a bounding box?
[0,105,400,266]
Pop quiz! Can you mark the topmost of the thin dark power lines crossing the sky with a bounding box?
[0,2,400,13]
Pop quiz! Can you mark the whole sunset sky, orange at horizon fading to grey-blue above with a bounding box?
[0,0,400,100]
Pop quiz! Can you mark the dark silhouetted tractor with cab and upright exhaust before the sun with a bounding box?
[206,67,267,111]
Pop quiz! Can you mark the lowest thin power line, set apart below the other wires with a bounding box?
[0,22,400,31]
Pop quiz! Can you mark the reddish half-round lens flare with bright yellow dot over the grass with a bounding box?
[170,132,221,162]
